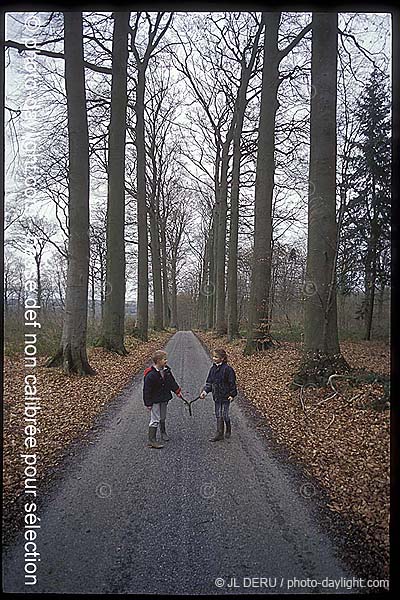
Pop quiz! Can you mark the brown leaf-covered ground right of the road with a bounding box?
[196,331,390,574]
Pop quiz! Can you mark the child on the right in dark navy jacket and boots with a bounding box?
[200,348,237,442]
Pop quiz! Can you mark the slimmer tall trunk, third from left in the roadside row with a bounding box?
[136,64,149,341]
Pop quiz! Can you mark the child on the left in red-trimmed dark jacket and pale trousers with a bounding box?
[143,350,181,448]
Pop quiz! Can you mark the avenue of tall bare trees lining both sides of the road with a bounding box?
[5,11,390,380]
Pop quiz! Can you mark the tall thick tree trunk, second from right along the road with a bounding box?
[245,12,281,354]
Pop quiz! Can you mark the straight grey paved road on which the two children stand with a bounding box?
[3,331,353,594]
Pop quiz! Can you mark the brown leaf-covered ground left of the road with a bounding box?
[3,331,173,528]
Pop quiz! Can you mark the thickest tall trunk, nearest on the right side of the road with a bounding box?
[299,12,348,384]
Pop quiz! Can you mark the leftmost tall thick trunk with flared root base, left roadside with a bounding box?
[47,12,95,375]
